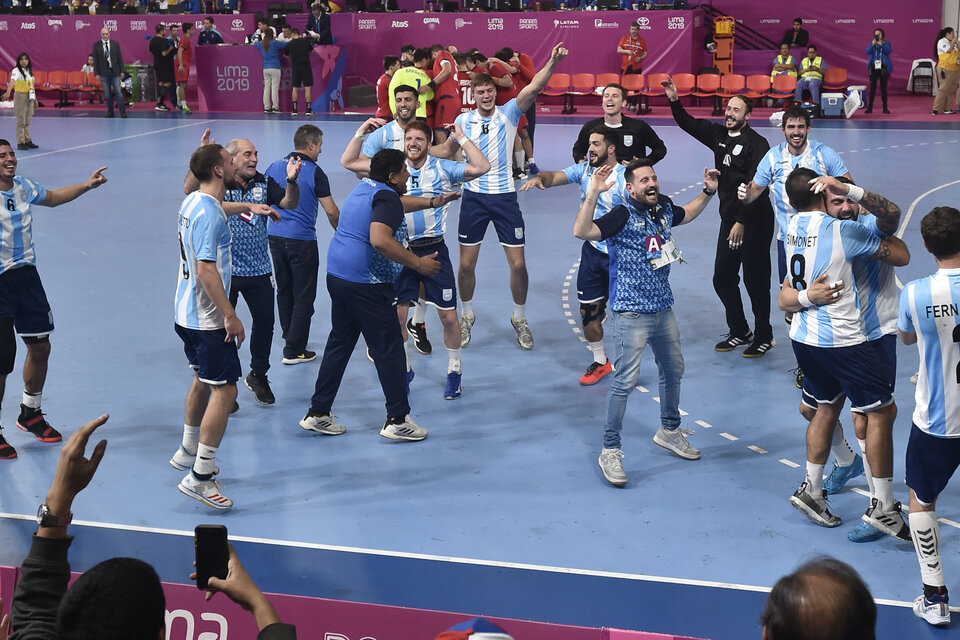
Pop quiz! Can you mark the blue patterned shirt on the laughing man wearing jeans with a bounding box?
[594,194,686,313]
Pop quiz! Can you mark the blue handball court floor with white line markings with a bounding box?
[0,110,960,640]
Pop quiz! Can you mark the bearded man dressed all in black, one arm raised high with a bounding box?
[664,78,775,358]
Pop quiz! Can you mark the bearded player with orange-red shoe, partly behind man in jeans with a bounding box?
[520,125,626,386]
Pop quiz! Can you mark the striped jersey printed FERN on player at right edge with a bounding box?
[899,269,960,438]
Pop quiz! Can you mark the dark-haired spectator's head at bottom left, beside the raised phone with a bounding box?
[57,556,165,640]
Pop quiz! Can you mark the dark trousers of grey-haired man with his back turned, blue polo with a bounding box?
[269,236,320,358]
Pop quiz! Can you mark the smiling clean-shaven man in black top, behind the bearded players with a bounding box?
[573,83,667,164]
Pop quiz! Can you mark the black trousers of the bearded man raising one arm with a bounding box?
[713,216,773,342]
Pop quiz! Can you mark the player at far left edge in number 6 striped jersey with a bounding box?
[0,139,107,460]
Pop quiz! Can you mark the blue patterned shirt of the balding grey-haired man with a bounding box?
[223,171,287,278]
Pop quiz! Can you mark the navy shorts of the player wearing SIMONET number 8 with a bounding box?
[791,340,893,412]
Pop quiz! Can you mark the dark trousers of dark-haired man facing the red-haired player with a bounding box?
[310,274,410,418]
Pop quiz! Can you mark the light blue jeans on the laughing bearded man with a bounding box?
[603,309,683,449]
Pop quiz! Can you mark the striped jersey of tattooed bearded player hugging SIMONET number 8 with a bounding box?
[853,213,900,340]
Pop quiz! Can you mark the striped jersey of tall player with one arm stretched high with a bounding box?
[456,98,523,193]
